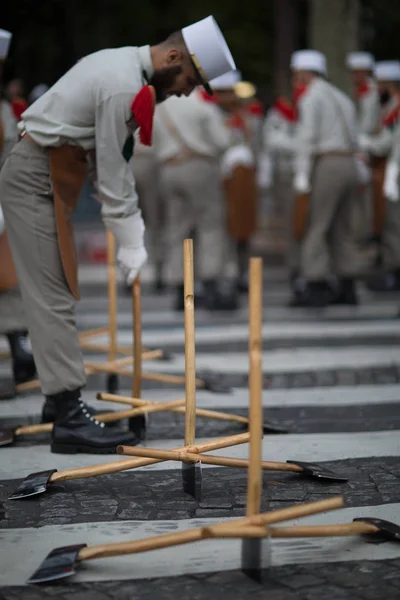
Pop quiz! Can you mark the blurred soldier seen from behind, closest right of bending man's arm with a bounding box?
[153,91,237,310]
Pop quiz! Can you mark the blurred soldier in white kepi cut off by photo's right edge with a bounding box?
[360,61,400,291]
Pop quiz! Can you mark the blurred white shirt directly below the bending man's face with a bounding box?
[153,91,230,162]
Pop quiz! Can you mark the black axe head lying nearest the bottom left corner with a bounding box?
[27,544,86,583]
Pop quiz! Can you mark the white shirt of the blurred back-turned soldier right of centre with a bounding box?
[295,78,357,177]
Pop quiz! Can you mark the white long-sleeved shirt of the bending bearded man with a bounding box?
[22,46,153,219]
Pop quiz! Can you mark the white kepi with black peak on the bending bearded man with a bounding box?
[182,16,236,95]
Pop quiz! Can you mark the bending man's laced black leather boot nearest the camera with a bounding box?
[51,389,140,454]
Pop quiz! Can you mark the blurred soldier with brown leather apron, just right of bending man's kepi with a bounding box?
[211,71,259,292]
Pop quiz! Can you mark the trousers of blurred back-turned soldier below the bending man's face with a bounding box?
[160,158,227,284]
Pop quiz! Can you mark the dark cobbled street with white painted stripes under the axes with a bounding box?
[0,268,400,600]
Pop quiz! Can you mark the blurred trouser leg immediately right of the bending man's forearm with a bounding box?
[132,154,165,264]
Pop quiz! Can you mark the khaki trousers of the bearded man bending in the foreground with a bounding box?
[0,138,85,395]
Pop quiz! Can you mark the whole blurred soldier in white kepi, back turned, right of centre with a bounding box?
[291,50,359,306]
